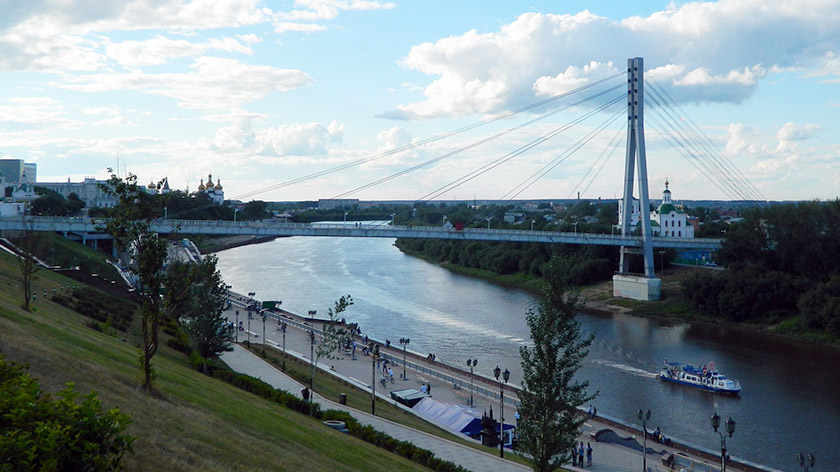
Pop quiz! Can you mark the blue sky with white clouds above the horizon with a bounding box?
[0,0,840,201]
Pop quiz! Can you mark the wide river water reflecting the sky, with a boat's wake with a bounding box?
[218,237,840,471]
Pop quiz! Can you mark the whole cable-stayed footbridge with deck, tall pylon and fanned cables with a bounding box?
[0,58,765,300]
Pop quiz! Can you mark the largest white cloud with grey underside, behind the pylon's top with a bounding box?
[390,0,840,119]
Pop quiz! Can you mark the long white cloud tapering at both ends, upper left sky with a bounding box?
[53,57,313,110]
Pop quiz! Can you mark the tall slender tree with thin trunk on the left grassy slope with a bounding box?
[102,169,167,390]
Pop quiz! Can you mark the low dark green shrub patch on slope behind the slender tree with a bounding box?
[52,287,137,332]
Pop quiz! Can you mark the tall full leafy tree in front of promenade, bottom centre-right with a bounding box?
[518,281,597,472]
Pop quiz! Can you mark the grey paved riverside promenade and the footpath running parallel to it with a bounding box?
[222,306,740,472]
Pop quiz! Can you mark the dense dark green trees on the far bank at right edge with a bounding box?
[682,200,840,336]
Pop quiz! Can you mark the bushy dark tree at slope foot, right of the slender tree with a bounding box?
[165,255,233,359]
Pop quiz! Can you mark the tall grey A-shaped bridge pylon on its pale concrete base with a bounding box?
[613,57,662,300]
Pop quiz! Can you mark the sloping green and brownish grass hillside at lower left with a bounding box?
[0,254,425,471]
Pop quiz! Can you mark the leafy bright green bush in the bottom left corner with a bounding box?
[0,356,134,472]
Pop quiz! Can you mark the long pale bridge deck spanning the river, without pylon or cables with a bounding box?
[0,216,720,251]
